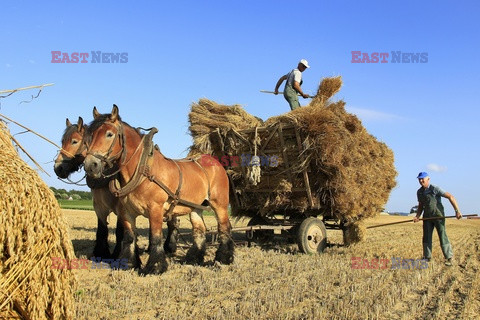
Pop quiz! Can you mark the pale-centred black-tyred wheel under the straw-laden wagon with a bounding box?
[297,217,327,254]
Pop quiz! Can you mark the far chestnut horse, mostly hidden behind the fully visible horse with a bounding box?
[54,117,178,259]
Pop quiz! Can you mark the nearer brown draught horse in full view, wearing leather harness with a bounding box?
[84,105,234,273]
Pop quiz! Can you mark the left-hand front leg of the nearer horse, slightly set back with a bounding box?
[119,215,140,269]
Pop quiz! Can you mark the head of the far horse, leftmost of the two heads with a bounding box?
[53,117,87,179]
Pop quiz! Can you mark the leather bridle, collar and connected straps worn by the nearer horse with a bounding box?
[87,122,210,220]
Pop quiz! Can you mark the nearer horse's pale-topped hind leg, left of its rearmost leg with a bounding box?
[185,209,207,265]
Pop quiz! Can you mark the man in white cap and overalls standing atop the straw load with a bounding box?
[274,59,310,110]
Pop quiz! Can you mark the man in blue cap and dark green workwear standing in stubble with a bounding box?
[413,172,462,266]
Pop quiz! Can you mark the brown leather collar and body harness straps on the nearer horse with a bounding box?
[103,127,210,220]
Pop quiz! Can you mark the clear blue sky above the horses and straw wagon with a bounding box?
[0,0,480,214]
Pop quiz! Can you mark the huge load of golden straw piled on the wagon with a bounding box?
[189,77,397,243]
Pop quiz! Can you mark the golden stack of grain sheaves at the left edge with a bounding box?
[0,121,76,319]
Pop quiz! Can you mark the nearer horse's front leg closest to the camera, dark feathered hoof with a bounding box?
[142,206,168,274]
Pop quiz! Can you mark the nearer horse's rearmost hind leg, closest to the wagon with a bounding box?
[210,201,234,264]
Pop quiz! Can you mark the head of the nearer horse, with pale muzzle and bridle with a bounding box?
[84,105,126,179]
